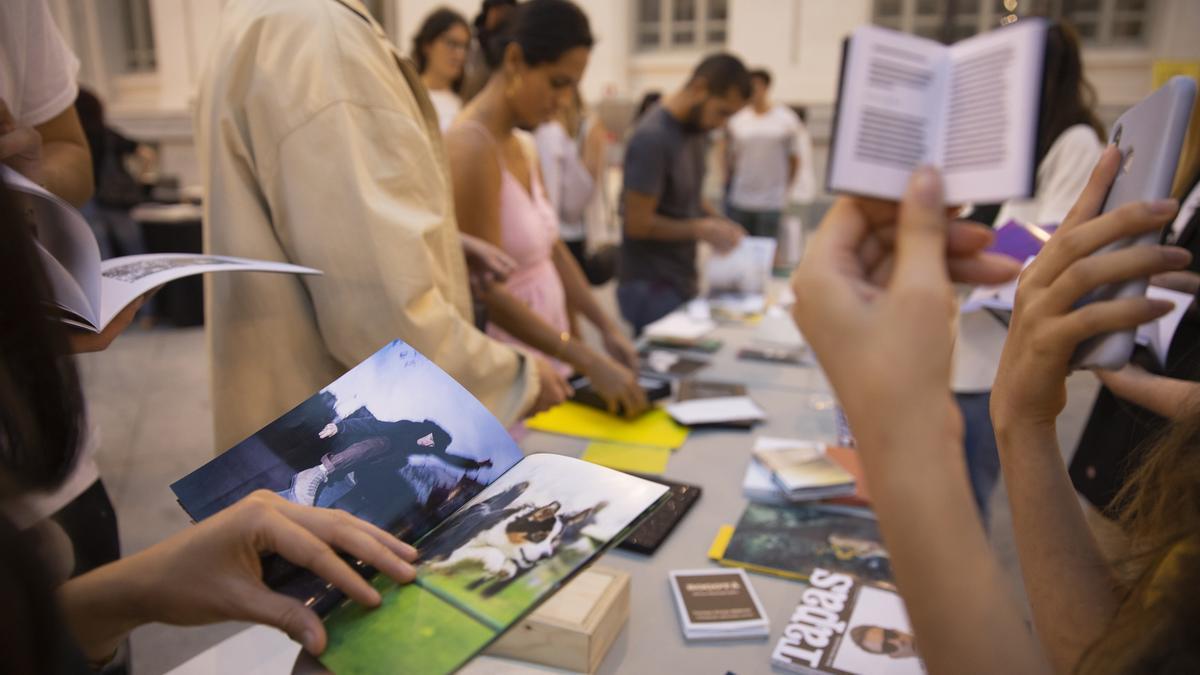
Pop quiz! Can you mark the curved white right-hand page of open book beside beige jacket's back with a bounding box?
[97,253,322,330]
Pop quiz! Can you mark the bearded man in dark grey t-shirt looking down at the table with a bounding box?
[617,54,750,333]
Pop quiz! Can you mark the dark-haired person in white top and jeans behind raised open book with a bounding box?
[952,22,1106,514]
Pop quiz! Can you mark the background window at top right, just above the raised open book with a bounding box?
[874,0,1156,47]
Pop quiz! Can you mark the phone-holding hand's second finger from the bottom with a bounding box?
[1046,246,1192,313]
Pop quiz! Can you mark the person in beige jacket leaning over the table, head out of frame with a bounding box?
[196,0,566,450]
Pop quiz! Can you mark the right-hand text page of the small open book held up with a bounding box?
[938,19,1045,204]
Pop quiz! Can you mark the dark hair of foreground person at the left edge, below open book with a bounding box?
[0,181,83,498]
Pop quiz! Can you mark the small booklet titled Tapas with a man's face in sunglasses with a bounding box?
[770,568,925,675]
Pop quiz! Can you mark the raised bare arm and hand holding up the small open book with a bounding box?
[793,180,1048,674]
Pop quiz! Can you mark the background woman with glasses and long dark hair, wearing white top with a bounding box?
[413,7,470,132]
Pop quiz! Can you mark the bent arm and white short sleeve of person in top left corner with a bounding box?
[0,0,94,207]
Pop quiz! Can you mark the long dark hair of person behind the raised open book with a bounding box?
[1034,22,1106,166]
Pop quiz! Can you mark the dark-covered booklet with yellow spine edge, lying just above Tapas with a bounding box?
[708,503,892,581]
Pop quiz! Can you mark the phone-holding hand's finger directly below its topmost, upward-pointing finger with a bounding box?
[1022,199,1178,287]
